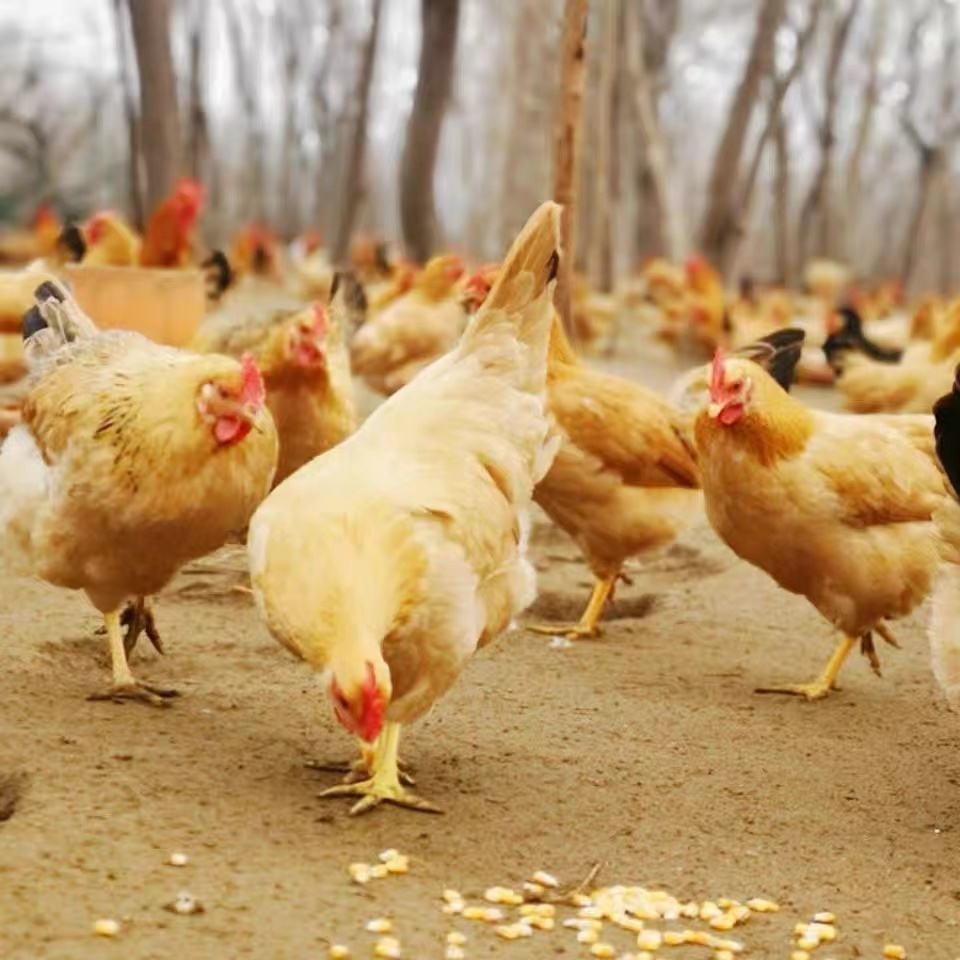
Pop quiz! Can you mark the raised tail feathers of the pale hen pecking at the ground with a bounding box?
[462,201,561,392]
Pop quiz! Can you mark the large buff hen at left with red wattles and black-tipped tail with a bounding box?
[0,284,277,705]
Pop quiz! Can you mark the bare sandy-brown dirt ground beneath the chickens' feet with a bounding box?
[0,334,960,960]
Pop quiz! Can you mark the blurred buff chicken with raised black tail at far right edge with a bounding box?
[823,302,960,413]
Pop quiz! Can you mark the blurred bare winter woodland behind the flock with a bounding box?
[0,0,960,292]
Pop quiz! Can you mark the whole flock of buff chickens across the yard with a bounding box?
[0,188,960,813]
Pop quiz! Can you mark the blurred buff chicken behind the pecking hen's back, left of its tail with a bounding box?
[350,254,466,396]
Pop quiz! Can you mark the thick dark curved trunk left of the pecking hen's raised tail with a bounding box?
[400,0,460,261]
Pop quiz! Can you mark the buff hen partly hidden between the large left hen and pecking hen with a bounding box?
[192,275,363,483]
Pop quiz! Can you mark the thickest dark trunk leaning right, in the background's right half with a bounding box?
[700,0,786,266]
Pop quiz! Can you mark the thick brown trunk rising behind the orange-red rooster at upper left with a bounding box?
[128,0,181,216]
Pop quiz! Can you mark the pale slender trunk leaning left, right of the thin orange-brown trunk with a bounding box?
[627,4,686,260]
